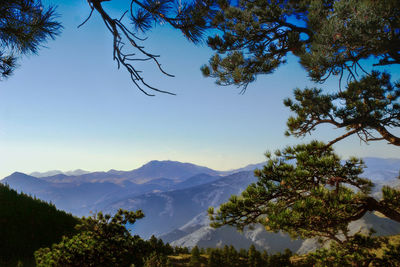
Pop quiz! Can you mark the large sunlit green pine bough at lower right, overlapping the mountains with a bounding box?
[210,141,400,242]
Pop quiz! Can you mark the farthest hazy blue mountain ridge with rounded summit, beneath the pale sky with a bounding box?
[1,161,228,215]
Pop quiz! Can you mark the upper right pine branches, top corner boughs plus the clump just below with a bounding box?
[202,0,400,146]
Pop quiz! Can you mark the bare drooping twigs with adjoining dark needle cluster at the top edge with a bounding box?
[82,0,219,96]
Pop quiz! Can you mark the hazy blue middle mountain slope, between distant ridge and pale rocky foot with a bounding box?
[102,172,255,238]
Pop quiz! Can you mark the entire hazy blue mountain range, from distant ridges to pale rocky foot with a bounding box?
[1,158,400,253]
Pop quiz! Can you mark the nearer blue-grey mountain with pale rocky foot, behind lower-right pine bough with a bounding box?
[98,158,400,253]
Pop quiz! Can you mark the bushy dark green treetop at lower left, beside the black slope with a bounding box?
[35,209,149,266]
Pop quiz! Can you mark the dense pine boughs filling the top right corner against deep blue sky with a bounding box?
[202,0,400,90]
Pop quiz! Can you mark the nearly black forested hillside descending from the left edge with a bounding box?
[0,184,79,266]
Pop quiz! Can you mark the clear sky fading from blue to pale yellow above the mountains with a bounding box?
[0,0,400,178]
